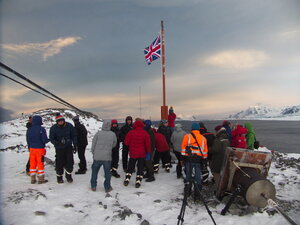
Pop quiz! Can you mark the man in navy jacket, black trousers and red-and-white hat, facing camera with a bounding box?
[49,115,77,184]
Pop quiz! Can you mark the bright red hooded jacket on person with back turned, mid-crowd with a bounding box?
[124,121,151,158]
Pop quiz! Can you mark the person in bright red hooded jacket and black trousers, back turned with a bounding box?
[124,120,151,188]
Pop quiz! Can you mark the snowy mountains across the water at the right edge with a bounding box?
[228,104,300,120]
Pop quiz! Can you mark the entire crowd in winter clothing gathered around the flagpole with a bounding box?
[26,107,255,197]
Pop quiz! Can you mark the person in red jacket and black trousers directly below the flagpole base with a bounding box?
[153,129,171,173]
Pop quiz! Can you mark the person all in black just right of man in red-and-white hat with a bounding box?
[73,116,88,174]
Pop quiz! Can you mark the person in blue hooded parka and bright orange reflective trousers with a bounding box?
[26,116,49,184]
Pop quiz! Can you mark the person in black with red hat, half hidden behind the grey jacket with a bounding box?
[110,120,120,178]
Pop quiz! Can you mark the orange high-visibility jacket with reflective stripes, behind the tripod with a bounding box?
[181,130,208,159]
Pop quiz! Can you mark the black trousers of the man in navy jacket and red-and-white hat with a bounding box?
[55,146,74,176]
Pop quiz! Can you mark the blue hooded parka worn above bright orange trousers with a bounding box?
[26,116,49,148]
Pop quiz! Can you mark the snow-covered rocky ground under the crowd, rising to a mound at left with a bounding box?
[0,109,300,225]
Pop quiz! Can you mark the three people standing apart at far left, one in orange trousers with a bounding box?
[26,114,88,184]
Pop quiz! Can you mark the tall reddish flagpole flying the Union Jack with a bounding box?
[161,21,168,120]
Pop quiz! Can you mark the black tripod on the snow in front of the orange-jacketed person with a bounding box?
[177,160,216,225]
